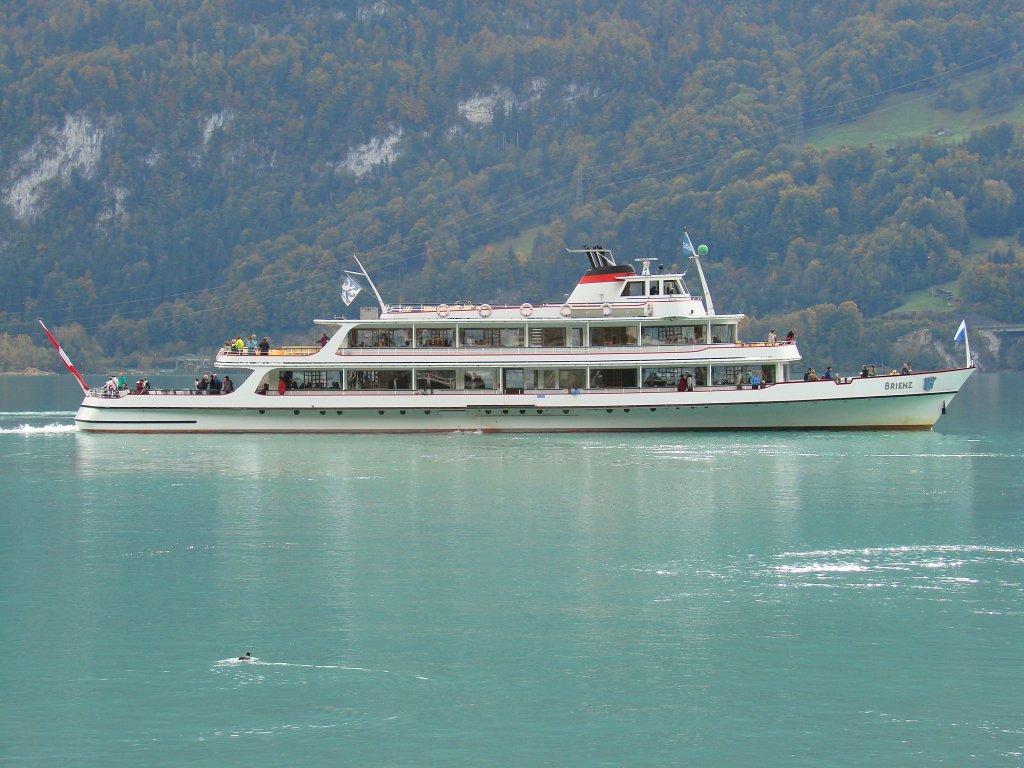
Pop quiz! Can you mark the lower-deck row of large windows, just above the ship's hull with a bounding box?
[265,365,775,391]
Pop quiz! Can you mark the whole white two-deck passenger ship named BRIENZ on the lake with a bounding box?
[68,237,974,433]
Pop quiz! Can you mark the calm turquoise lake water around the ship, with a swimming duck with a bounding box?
[0,375,1024,768]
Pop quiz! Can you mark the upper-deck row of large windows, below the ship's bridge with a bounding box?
[347,325,736,347]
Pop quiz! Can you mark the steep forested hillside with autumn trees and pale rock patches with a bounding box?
[0,0,1024,370]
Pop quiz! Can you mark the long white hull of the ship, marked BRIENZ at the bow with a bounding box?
[75,368,974,433]
